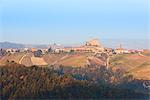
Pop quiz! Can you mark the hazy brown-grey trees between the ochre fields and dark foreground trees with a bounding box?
[55,65,137,85]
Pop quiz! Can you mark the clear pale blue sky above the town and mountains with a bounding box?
[0,0,150,48]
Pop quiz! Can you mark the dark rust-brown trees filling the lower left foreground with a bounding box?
[0,63,147,99]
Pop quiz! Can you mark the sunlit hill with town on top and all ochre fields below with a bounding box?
[0,39,150,79]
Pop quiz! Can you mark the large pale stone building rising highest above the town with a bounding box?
[63,39,104,52]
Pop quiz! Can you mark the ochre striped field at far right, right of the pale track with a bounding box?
[110,54,150,80]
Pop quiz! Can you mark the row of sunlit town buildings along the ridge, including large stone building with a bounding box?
[0,39,143,55]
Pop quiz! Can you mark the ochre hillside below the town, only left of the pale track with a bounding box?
[0,53,103,67]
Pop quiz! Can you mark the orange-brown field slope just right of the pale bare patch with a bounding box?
[43,53,91,67]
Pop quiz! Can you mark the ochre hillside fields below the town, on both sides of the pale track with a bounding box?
[0,52,150,80]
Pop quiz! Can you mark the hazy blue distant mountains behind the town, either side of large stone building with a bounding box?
[0,39,150,49]
